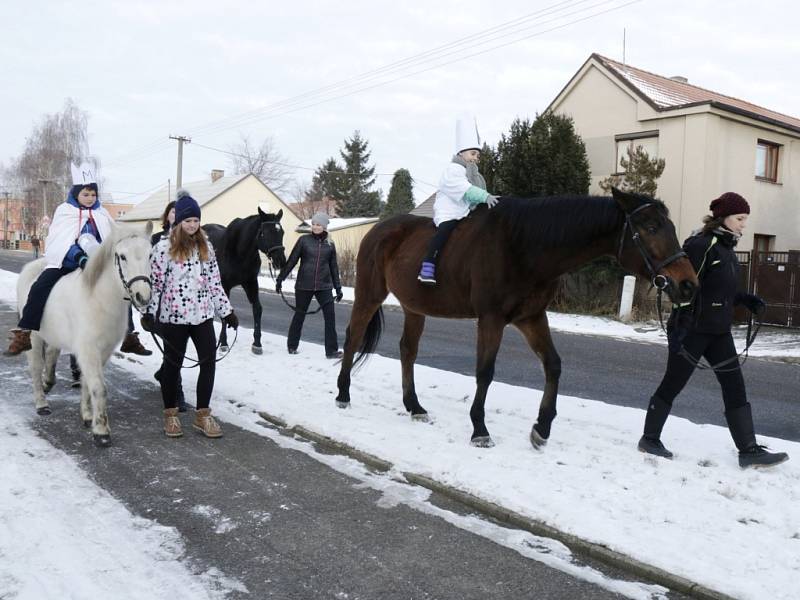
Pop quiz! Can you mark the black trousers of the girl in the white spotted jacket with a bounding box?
[158,319,217,408]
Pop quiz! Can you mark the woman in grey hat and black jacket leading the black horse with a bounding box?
[275,213,342,358]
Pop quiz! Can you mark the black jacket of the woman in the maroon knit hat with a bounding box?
[673,230,741,334]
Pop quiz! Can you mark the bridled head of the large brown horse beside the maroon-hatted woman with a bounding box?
[611,188,698,302]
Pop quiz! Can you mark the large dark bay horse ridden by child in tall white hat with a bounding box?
[336,189,698,448]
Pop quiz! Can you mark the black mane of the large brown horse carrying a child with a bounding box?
[487,194,668,250]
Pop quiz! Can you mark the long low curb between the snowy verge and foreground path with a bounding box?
[258,411,736,600]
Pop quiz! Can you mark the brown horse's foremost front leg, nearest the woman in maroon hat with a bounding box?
[514,311,561,448]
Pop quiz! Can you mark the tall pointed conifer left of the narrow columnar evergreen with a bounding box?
[336,130,381,217]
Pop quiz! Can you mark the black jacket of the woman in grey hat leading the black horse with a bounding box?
[278,232,342,291]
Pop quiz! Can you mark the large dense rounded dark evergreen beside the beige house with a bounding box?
[494,112,590,197]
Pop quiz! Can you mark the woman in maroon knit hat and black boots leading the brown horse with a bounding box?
[639,192,789,468]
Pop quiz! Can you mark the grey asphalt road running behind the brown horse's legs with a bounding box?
[0,251,800,444]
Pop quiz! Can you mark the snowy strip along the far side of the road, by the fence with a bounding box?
[258,276,800,366]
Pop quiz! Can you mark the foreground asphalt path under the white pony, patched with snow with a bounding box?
[0,305,683,600]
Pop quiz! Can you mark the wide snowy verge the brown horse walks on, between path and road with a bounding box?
[0,272,800,600]
